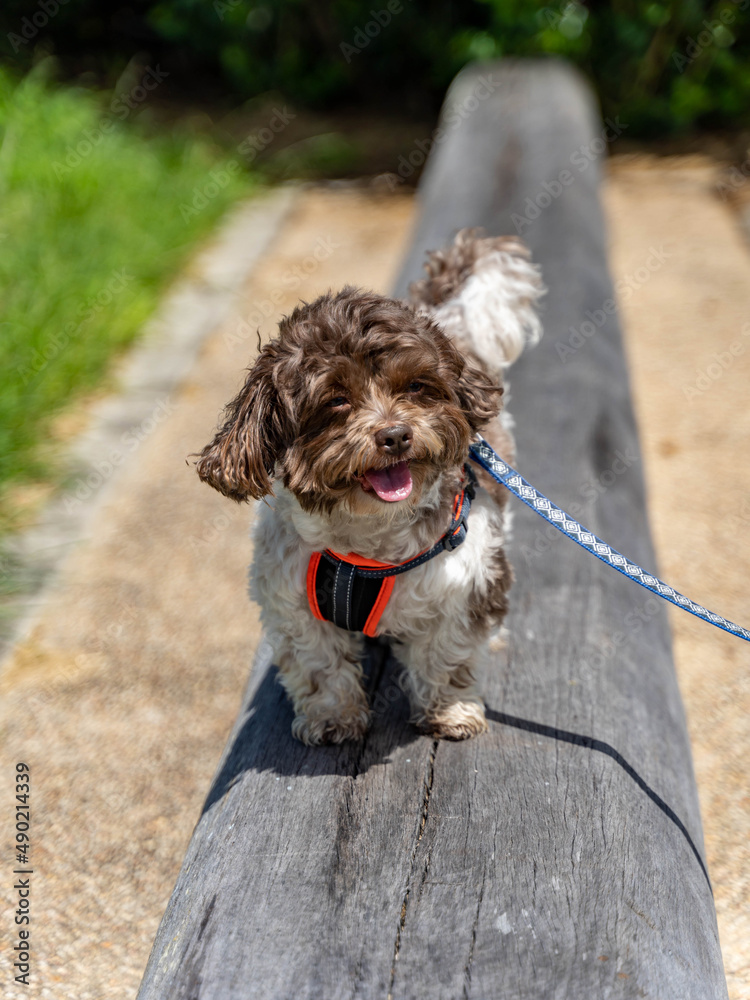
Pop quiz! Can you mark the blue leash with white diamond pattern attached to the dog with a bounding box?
[469,436,750,642]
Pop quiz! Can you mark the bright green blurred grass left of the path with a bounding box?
[0,70,255,533]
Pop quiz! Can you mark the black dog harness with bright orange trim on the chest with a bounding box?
[307,465,477,636]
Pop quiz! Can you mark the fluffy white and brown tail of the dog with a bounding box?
[409,229,545,373]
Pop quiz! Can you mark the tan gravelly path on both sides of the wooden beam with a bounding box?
[0,168,750,1000]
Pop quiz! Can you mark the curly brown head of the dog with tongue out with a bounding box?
[197,288,502,515]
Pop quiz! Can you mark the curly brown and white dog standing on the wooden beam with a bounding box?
[197,230,543,743]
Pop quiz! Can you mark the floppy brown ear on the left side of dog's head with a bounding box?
[196,345,289,502]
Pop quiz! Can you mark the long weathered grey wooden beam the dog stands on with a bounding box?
[139,63,727,1000]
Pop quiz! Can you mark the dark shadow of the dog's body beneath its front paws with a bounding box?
[203,643,424,812]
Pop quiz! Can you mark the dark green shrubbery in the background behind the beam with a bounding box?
[0,0,750,136]
